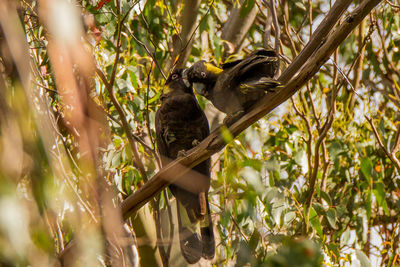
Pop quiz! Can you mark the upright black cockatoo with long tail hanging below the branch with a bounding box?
[155,70,215,264]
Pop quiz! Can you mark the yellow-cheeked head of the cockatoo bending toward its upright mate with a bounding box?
[185,60,222,95]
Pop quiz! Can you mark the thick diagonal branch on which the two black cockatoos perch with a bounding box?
[121,0,381,218]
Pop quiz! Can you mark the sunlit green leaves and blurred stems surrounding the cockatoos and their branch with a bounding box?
[0,0,400,266]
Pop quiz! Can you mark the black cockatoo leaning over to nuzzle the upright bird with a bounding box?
[185,49,280,125]
